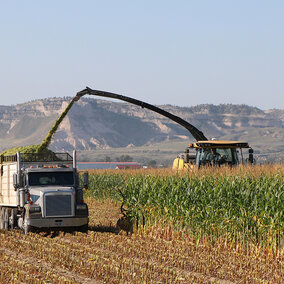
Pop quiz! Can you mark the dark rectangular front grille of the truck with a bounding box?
[45,194,72,217]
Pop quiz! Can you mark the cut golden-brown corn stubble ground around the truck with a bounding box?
[0,199,284,283]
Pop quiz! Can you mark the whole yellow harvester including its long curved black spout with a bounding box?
[73,87,254,169]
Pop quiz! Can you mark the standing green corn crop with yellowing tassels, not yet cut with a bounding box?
[84,165,284,253]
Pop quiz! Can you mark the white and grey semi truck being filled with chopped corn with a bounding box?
[0,151,89,234]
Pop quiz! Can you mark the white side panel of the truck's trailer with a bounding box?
[0,163,17,206]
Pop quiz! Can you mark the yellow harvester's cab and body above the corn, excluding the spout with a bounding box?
[173,140,254,170]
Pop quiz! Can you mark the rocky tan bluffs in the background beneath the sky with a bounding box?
[0,98,284,160]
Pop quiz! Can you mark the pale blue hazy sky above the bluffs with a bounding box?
[0,0,284,109]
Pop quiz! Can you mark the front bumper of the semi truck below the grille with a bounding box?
[27,217,89,228]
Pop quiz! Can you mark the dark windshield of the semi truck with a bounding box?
[28,172,74,186]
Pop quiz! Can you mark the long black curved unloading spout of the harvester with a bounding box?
[74,87,208,141]
